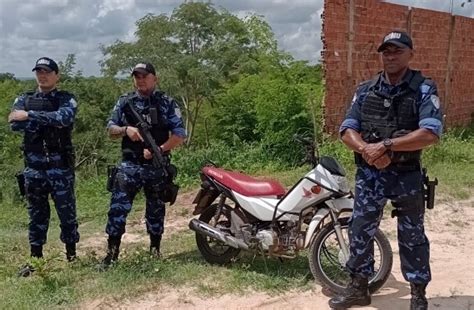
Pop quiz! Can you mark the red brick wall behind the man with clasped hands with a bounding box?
[322,0,474,133]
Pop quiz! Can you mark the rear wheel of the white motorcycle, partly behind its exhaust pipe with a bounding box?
[196,204,240,265]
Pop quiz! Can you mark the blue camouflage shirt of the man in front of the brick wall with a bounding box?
[339,69,443,137]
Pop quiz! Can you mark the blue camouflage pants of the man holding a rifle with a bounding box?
[105,162,165,237]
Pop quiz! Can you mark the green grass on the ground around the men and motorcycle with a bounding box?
[0,128,474,309]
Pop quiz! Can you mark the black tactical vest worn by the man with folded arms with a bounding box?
[21,91,74,168]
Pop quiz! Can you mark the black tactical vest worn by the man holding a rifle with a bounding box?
[122,92,171,163]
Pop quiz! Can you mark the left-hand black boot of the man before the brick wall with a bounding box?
[329,275,372,309]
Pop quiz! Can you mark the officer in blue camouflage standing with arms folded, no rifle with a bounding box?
[8,57,79,276]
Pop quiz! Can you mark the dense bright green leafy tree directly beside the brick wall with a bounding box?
[206,60,322,163]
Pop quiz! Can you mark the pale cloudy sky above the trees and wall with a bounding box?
[0,0,474,77]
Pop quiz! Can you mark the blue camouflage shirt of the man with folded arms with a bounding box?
[11,89,77,178]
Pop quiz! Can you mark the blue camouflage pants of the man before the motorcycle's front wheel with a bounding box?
[346,167,431,284]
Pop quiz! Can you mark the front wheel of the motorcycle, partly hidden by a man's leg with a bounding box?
[308,217,393,293]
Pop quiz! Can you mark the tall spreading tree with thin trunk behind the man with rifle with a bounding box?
[101,2,278,144]
